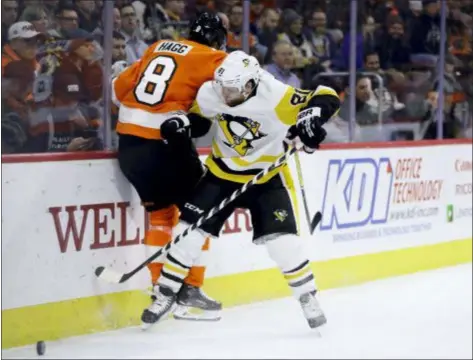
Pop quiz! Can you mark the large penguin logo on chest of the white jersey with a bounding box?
[217,114,266,156]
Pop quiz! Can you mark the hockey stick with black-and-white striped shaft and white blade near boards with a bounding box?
[95,147,297,284]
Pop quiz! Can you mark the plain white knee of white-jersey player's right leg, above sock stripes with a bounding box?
[265,234,306,270]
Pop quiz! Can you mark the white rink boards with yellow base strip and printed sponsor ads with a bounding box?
[2,140,472,348]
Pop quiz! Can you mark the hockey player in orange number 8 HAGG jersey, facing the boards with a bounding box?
[112,13,226,320]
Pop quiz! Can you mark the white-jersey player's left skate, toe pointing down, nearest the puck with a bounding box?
[141,286,176,330]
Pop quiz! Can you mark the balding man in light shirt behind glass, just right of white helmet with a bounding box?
[266,40,301,88]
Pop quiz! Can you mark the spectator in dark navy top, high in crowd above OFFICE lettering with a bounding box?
[376,16,410,70]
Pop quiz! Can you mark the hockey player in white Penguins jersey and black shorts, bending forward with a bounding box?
[142,51,340,328]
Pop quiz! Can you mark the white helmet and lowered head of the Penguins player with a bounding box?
[214,50,261,105]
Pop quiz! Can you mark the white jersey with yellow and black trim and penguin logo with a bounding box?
[190,71,338,183]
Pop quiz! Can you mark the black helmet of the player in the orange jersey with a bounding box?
[189,12,227,50]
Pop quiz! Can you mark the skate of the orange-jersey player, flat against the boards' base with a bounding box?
[174,284,222,321]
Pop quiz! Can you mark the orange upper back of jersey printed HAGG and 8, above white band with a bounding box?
[114,40,227,113]
